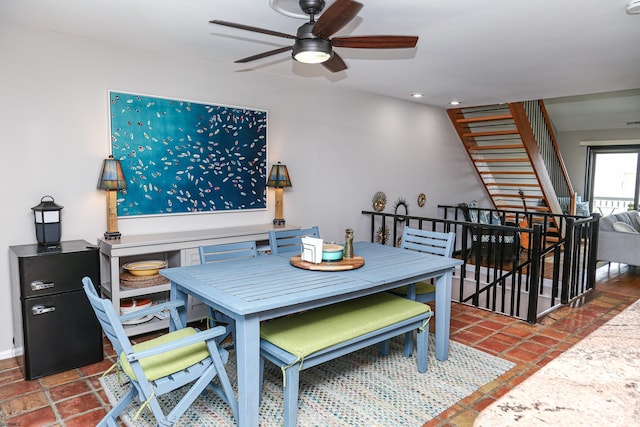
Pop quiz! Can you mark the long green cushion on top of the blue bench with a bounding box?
[260,292,431,359]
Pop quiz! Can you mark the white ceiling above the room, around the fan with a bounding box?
[0,0,640,130]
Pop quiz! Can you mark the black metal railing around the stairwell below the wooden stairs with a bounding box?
[362,206,600,322]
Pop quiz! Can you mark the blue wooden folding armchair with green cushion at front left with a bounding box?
[82,277,238,427]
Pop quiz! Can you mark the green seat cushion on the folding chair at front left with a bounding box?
[120,328,209,381]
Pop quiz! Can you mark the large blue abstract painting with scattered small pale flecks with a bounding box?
[109,91,267,216]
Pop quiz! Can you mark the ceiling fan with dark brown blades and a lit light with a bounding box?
[209,0,418,73]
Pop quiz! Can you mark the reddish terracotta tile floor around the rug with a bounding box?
[0,264,640,427]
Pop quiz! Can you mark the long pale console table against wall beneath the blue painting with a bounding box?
[98,224,300,336]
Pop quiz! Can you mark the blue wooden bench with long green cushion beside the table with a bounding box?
[260,292,431,427]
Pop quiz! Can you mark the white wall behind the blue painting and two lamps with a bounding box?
[0,21,482,357]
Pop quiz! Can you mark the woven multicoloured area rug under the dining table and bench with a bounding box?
[100,336,514,427]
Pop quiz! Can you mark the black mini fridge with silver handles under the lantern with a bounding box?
[9,240,103,380]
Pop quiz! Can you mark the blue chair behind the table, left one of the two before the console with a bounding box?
[198,241,258,344]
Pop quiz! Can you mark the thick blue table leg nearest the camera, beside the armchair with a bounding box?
[235,315,260,427]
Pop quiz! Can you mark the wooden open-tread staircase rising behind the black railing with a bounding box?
[447,101,575,234]
